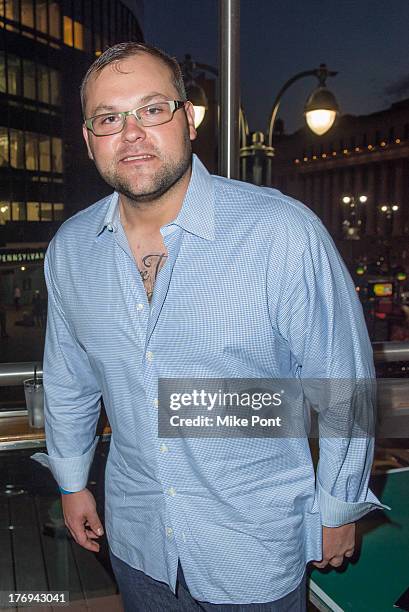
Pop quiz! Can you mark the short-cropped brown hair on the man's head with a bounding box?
[80,42,186,117]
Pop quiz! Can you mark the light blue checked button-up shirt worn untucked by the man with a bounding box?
[34,157,381,604]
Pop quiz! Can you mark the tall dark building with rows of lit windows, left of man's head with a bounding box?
[0,0,143,299]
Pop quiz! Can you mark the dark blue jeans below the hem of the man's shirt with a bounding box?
[109,551,307,612]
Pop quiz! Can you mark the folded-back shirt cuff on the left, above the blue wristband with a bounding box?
[30,437,99,493]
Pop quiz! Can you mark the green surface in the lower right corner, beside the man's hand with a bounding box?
[310,468,409,612]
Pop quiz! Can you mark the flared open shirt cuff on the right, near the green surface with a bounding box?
[317,480,390,527]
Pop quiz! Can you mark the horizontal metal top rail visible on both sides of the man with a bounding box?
[0,342,409,387]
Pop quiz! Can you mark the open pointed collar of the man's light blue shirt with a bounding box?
[97,155,215,240]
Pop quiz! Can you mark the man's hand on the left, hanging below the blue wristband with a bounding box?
[61,489,104,552]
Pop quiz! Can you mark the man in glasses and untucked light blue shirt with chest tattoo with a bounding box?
[31,43,379,611]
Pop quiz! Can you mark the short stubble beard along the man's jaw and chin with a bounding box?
[100,135,192,208]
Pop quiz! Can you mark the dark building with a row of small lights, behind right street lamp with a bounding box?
[273,100,409,260]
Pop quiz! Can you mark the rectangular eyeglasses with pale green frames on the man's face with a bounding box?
[84,100,185,136]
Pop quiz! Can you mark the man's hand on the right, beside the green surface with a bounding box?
[313,523,355,569]
